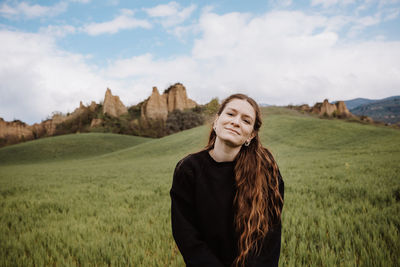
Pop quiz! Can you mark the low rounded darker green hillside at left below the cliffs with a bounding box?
[0,133,151,165]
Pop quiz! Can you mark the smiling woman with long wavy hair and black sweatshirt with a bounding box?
[170,94,284,267]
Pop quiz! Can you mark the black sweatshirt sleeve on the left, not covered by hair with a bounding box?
[170,161,224,267]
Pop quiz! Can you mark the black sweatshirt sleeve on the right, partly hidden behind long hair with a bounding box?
[249,172,285,267]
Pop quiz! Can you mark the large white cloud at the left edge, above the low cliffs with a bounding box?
[0,30,110,123]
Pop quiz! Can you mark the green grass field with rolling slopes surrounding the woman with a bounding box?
[0,108,400,266]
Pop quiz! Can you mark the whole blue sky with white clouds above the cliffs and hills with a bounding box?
[0,0,400,124]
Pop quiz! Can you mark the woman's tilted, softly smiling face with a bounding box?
[214,98,256,147]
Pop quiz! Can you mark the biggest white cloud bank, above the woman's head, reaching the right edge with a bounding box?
[104,11,400,105]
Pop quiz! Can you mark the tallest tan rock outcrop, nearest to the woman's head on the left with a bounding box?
[141,83,197,121]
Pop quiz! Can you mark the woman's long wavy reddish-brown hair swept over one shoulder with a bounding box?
[205,94,283,266]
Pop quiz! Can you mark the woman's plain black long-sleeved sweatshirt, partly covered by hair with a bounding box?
[170,150,284,267]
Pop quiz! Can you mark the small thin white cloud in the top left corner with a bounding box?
[0,2,68,19]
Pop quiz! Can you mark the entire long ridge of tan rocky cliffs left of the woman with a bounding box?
[0,83,197,147]
